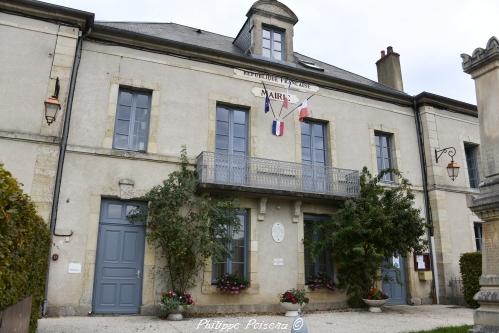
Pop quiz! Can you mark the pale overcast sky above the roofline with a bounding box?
[48,0,499,103]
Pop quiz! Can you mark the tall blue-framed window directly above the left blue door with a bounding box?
[113,88,151,151]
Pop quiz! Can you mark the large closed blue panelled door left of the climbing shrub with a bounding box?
[93,201,145,314]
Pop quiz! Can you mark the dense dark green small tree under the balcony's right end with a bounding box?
[305,167,425,306]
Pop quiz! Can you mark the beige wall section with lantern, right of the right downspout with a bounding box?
[421,105,480,303]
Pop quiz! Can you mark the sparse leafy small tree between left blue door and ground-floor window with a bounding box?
[130,147,239,293]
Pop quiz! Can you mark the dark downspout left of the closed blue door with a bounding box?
[42,28,90,316]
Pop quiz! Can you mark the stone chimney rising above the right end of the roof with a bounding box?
[376,46,404,91]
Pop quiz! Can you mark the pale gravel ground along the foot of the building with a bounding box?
[37,305,473,333]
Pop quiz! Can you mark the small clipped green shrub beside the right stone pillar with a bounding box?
[459,252,482,308]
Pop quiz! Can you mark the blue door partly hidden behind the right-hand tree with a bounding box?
[383,255,407,304]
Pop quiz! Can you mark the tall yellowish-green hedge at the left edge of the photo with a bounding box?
[0,164,50,333]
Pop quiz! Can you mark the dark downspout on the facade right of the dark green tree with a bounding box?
[412,97,440,304]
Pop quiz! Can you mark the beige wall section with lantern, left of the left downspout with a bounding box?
[0,13,79,221]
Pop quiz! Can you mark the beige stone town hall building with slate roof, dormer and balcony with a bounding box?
[0,0,481,315]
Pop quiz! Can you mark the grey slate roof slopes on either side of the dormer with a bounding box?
[95,21,406,95]
